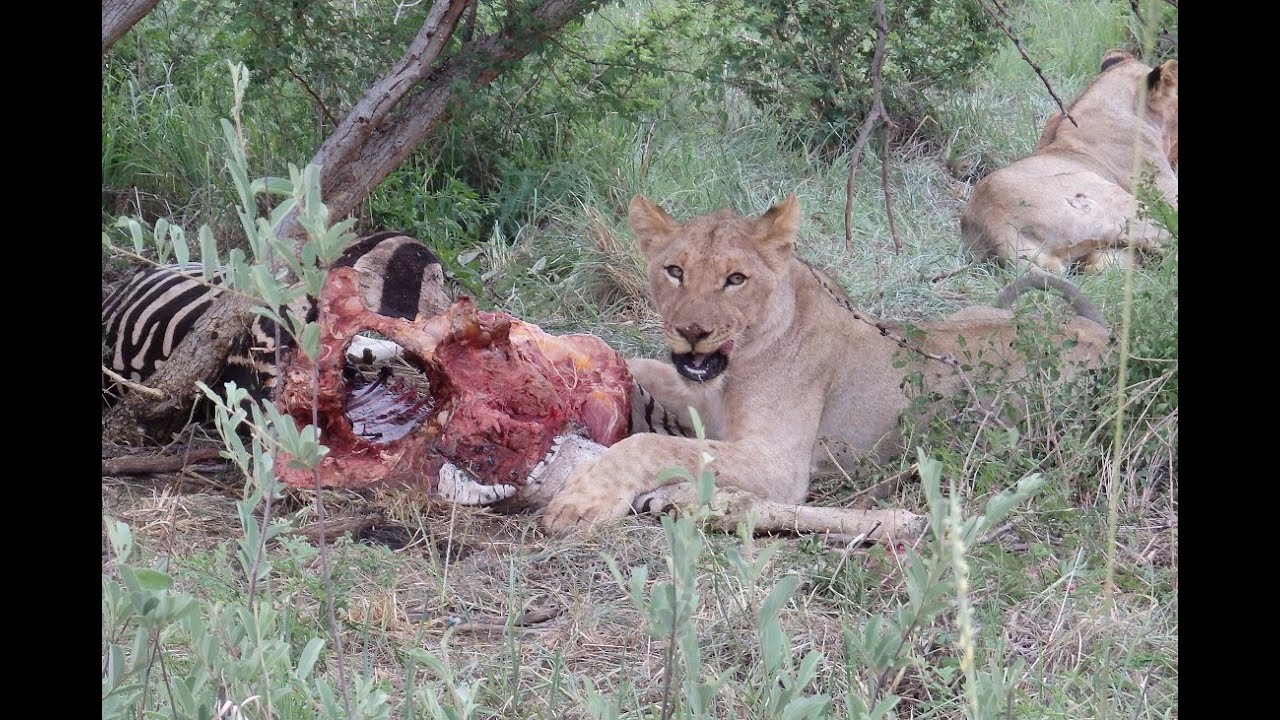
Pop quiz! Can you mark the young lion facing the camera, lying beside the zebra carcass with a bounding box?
[544,195,1110,529]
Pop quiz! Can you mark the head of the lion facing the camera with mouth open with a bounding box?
[628,195,800,382]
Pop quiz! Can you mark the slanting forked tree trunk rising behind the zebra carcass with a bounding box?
[276,0,600,247]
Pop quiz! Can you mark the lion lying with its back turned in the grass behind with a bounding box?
[960,50,1178,273]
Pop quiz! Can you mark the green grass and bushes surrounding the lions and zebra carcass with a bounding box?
[102,0,1178,719]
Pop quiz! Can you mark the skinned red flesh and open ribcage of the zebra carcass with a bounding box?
[276,268,632,507]
